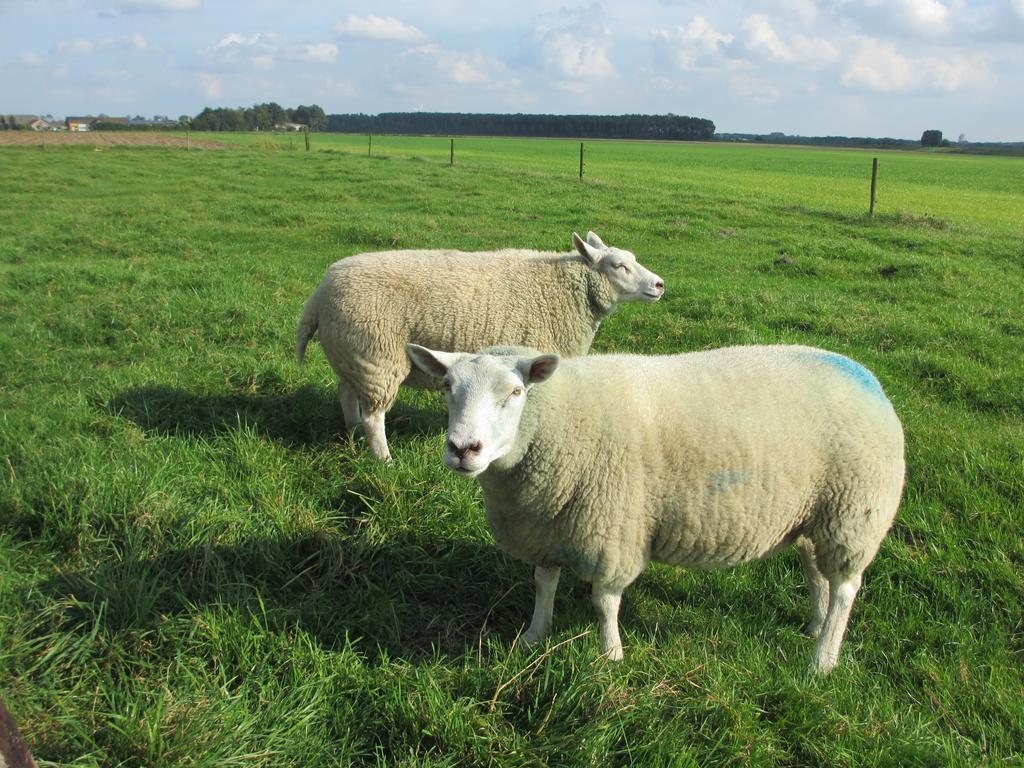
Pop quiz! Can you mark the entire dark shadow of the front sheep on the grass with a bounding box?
[38,534,811,664]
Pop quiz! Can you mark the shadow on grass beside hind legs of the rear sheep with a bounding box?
[105,384,445,446]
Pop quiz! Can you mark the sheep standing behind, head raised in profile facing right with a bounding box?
[296,231,665,461]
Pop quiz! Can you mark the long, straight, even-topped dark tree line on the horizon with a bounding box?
[327,112,715,140]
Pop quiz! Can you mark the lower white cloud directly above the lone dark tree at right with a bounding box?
[841,38,995,93]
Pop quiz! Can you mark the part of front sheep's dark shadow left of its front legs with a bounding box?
[39,535,532,663]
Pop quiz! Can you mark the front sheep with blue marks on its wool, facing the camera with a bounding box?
[408,344,904,674]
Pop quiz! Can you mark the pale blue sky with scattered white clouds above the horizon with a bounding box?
[0,0,1024,141]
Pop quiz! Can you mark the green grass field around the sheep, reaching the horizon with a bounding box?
[0,135,1024,767]
